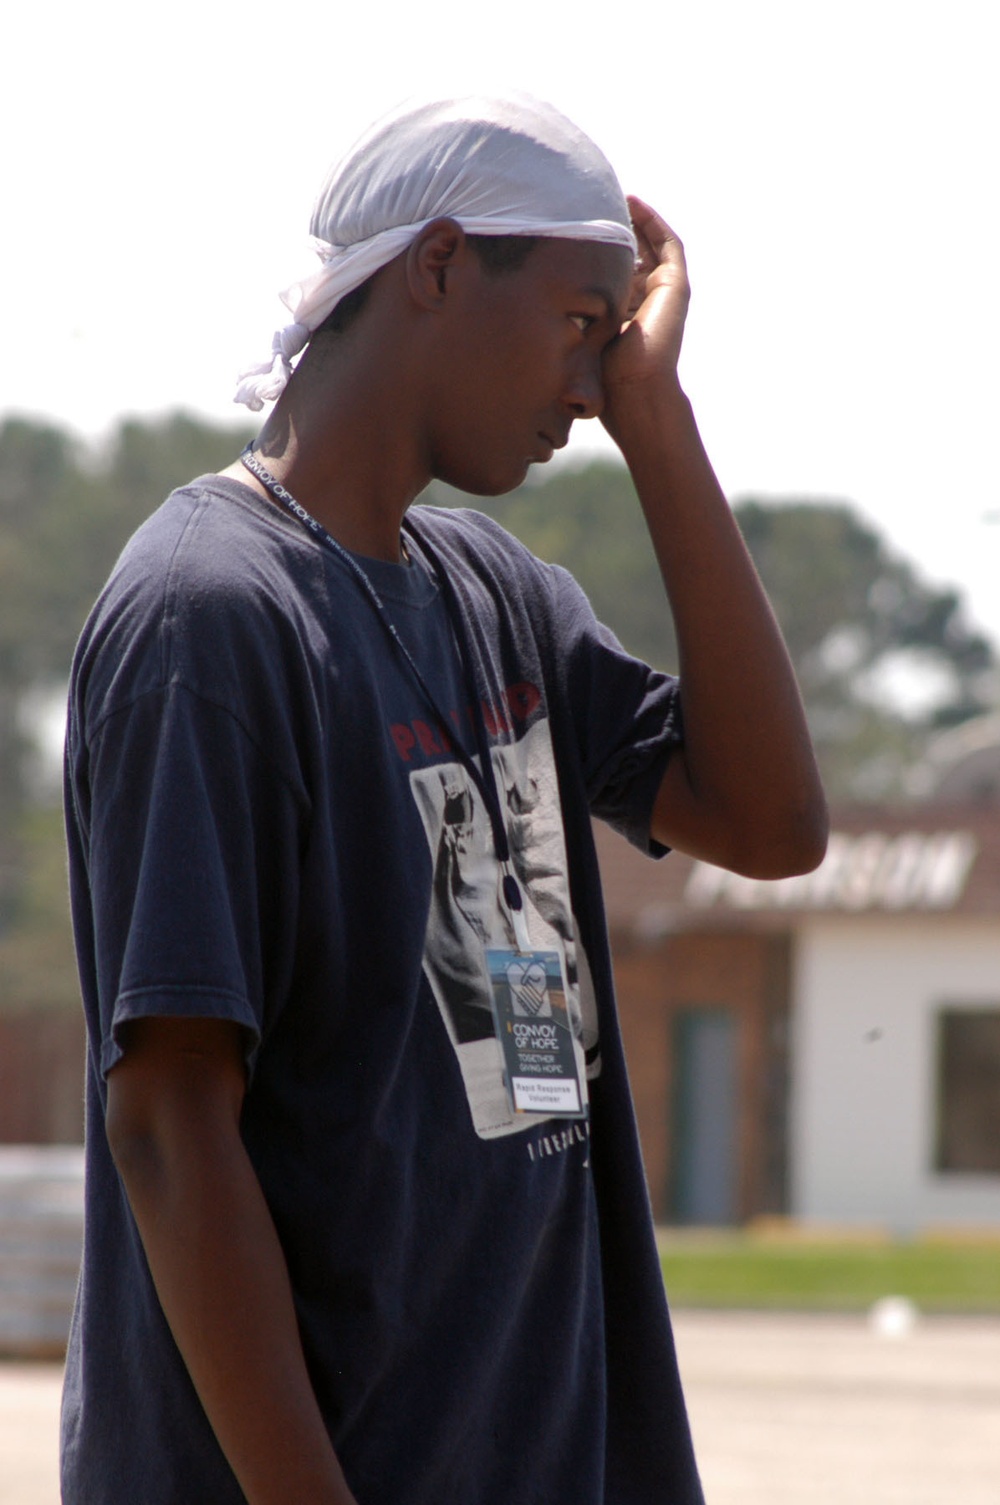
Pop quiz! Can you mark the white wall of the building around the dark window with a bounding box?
[789,915,1000,1233]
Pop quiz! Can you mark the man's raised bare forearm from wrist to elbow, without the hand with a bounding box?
[616,387,827,877]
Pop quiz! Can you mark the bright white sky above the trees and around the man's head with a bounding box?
[7,0,1000,640]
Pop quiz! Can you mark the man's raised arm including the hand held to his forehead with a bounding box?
[602,199,827,877]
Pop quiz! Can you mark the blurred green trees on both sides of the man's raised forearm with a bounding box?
[448,462,997,799]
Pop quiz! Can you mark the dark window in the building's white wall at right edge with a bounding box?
[934,1008,1000,1175]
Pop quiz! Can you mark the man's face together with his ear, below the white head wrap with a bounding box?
[394,220,633,495]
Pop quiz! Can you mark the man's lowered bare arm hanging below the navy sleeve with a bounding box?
[107,1019,355,1505]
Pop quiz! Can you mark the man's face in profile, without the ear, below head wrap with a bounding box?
[429,239,633,497]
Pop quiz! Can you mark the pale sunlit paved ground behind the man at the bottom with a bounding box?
[0,1312,1000,1505]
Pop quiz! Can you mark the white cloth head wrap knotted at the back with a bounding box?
[235,93,637,412]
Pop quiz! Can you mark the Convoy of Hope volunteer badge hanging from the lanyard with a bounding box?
[486,950,587,1118]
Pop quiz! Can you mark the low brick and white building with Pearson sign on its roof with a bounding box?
[598,790,1000,1233]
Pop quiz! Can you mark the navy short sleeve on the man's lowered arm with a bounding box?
[86,682,300,1073]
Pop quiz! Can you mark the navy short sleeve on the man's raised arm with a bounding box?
[553,566,684,856]
